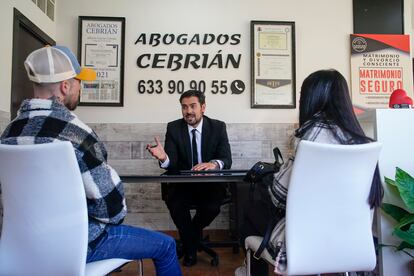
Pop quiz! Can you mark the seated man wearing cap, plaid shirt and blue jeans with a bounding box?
[0,46,181,275]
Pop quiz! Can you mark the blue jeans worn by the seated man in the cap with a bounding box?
[86,225,181,276]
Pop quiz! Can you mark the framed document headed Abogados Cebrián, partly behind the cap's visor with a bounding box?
[78,16,125,106]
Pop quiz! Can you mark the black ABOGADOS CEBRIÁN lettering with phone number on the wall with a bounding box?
[134,32,246,95]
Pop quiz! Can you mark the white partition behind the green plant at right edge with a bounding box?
[374,109,414,276]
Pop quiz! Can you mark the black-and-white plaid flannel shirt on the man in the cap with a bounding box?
[0,98,127,246]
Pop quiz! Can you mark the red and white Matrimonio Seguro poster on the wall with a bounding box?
[350,34,413,108]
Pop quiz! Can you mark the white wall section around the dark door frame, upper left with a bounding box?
[0,0,56,112]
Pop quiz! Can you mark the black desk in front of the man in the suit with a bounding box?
[121,170,249,241]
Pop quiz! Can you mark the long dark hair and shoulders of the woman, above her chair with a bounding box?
[295,70,383,208]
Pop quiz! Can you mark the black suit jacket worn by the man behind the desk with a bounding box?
[164,116,232,171]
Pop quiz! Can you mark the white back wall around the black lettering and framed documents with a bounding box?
[56,0,353,123]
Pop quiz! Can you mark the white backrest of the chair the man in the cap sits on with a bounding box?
[0,142,88,275]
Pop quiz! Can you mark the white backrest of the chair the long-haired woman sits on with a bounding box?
[286,141,381,275]
